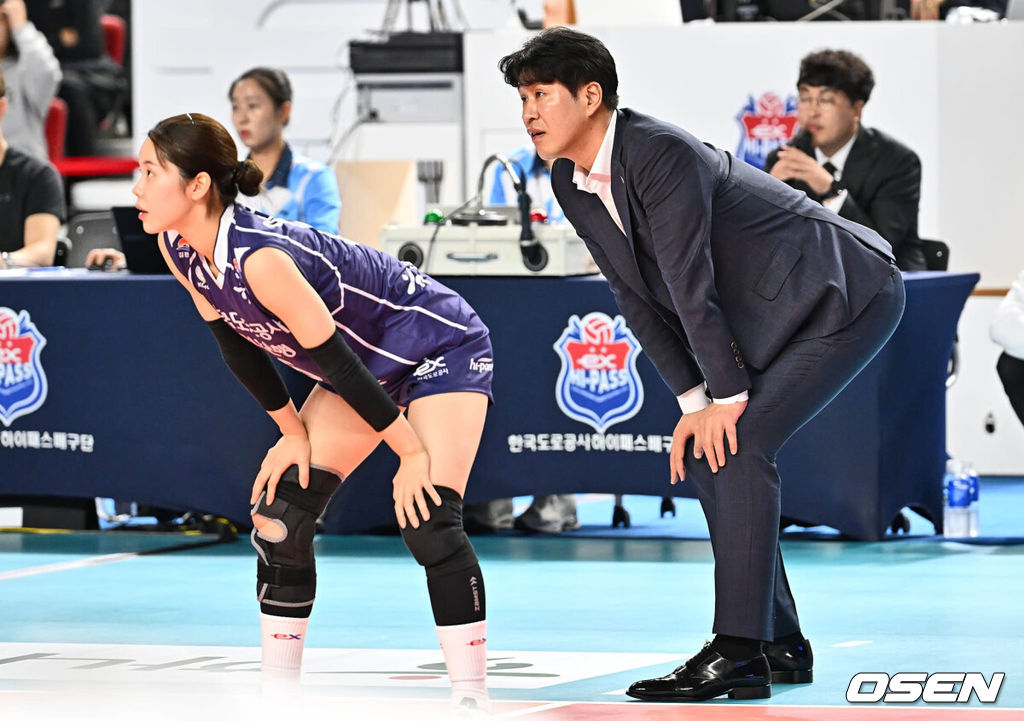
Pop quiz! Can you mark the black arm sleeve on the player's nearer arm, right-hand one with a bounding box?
[306,331,401,431]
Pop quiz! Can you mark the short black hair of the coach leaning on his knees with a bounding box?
[498,28,618,111]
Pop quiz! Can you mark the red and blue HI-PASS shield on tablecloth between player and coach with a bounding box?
[554,312,643,433]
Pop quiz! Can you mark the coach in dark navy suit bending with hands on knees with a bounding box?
[499,28,904,701]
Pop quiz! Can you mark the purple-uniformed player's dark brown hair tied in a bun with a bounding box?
[148,113,263,208]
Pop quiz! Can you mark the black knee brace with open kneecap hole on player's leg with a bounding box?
[251,466,342,619]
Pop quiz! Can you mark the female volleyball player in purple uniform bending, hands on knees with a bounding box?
[132,113,494,708]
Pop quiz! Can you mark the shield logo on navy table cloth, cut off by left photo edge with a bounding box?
[0,307,46,426]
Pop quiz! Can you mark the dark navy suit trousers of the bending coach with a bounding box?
[684,265,905,641]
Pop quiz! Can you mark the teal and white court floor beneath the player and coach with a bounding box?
[0,479,1024,721]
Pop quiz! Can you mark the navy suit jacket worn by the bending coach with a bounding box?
[551,110,892,397]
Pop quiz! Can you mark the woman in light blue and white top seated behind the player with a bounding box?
[227,68,341,232]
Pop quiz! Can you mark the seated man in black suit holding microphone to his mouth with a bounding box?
[765,50,925,270]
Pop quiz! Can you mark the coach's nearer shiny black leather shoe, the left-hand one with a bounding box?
[626,643,771,701]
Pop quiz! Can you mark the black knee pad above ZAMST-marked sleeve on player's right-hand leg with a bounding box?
[401,485,476,577]
